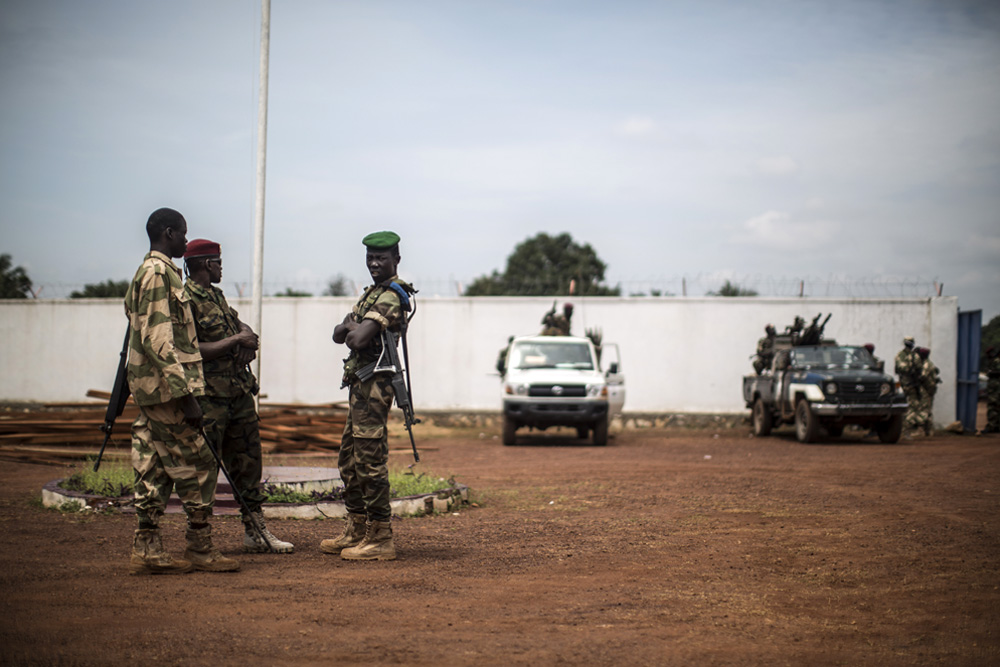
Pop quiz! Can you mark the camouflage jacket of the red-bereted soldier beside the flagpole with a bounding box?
[184,278,257,396]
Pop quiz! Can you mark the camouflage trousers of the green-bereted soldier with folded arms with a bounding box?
[337,376,393,521]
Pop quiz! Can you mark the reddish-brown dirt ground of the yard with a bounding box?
[0,420,1000,665]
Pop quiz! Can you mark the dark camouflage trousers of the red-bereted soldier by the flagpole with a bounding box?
[198,394,264,519]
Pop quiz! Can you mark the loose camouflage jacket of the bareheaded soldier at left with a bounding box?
[125,252,205,405]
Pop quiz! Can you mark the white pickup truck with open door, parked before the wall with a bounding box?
[501,336,625,445]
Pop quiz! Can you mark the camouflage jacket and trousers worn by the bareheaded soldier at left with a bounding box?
[125,251,218,528]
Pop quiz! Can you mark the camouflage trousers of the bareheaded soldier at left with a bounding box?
[132,400,219,527]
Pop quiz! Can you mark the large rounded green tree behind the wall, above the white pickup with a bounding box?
[465,232,621,296]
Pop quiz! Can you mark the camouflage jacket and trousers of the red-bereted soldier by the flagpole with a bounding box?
[184,279,265,522]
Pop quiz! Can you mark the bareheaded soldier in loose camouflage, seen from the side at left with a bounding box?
[125,208,240,574]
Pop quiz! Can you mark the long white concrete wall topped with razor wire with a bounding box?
[0,297,958,424]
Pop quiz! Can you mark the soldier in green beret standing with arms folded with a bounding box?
[320,232,415,560]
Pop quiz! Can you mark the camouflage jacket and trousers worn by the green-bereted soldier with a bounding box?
[337,276,412,521]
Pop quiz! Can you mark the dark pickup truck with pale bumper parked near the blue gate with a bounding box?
[743,341,907,443]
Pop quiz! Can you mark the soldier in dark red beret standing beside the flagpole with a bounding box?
[184,239,294,553]
